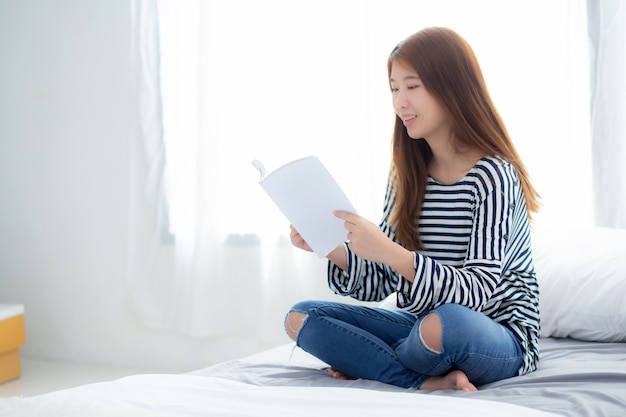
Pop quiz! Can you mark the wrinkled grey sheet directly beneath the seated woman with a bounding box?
[194,338,626,417]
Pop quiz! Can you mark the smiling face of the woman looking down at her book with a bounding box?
[389,61,451,142]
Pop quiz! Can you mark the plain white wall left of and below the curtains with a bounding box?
[0,0,276,371]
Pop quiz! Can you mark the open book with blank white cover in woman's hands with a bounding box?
[252,156,356,257]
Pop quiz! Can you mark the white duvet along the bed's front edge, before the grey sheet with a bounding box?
[0,374,553,417]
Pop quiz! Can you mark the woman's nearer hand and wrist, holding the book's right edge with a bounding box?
[334,210,395,263]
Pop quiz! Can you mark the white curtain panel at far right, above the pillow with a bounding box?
[587,0,626,229]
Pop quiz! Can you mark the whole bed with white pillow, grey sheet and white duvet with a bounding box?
[0,228,626,417]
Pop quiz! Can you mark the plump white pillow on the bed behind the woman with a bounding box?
[533,228,626,342]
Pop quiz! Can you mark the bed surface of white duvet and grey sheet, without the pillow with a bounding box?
[0,338,626,417]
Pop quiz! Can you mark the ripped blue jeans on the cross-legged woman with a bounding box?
[291,301,523,388]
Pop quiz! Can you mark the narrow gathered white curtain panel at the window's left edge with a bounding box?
[126,0,176,327]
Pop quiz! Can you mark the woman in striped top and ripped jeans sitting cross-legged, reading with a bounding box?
[285,28,539,391]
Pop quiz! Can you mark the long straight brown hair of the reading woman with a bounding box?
[387,27,539,250]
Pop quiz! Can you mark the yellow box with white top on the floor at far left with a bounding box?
[0,304,26,384]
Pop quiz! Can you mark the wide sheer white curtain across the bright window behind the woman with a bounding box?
[128,0,593,344]
